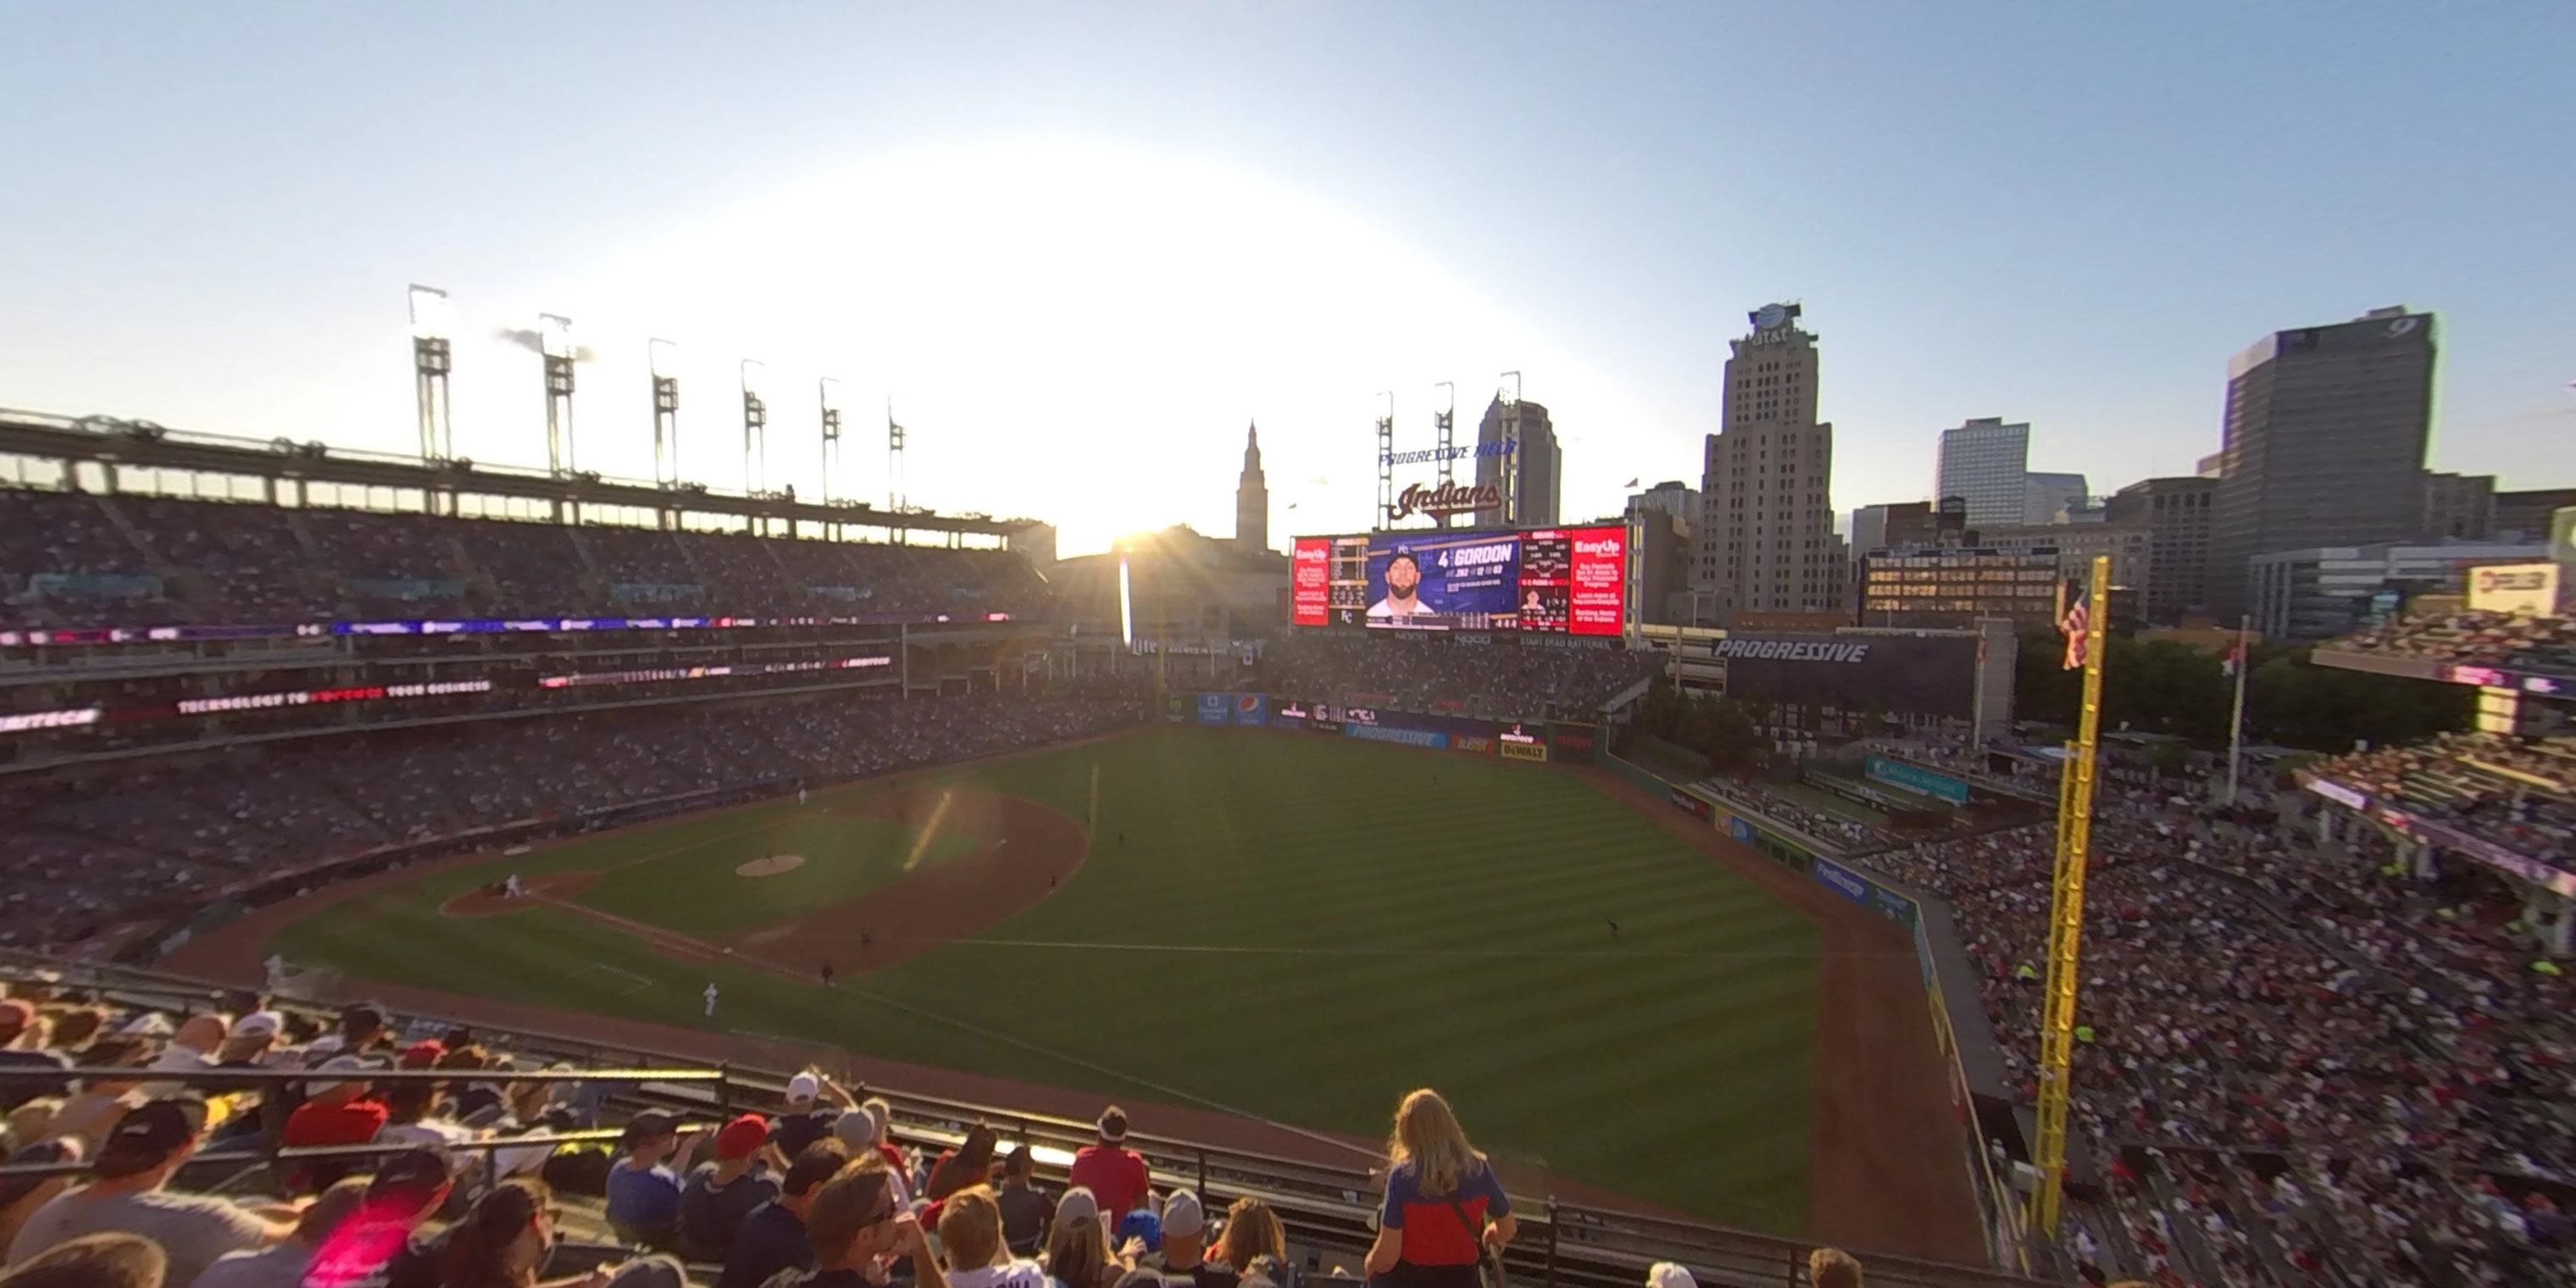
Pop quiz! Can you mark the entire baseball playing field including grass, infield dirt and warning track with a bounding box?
[173,726,1981,1260]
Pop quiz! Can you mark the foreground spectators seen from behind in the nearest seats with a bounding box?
[0,971,1863,1288]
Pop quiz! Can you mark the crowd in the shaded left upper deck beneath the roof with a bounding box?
[0,487,1048,629]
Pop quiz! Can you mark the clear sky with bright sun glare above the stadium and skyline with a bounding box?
[0,0,2576,549]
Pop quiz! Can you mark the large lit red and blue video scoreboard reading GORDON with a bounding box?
[1291,528,1628,636]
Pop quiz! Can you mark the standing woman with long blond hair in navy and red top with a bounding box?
[1368,1087,1520,1288]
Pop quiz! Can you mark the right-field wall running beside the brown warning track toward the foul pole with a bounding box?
[1600,752,2030,1270]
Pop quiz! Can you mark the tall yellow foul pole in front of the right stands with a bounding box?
[2030,557,2110,1239]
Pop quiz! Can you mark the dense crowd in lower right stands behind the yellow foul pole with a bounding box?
[1863,752,2576,1285]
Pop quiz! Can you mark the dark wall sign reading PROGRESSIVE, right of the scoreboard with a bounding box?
[1711,634,1979,719]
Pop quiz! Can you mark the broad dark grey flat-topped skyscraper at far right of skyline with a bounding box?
[2210,307,2437,621]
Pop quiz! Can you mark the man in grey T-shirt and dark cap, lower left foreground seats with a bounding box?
[8,1097,294,1283]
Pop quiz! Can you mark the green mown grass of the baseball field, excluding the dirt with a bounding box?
[273,726,1818,1236]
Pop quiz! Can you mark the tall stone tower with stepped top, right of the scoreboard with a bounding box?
[1692,304,1844,626]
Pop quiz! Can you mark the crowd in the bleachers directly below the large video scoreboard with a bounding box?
[1244,634,1654,719]
